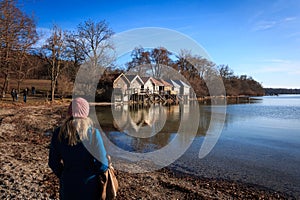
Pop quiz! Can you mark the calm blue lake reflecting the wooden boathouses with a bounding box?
[96,95,300,198]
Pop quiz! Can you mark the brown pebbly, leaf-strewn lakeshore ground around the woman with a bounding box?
[0,102,293,200]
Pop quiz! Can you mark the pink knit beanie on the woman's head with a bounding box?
[68,97,90,118]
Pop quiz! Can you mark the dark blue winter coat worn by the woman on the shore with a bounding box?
[49,128,108,200]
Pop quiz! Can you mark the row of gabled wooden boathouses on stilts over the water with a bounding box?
[112,73,190,104]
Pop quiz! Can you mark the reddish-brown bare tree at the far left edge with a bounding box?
[0,0,37,91]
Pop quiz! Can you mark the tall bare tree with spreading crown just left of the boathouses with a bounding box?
[69,20,115,97]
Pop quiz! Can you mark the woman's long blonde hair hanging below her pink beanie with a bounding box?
[58,117,93,146]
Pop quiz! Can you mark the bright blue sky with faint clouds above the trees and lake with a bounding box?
[18,0,300,88]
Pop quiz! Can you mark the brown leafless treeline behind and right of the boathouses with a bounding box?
[125,47,265,97]
